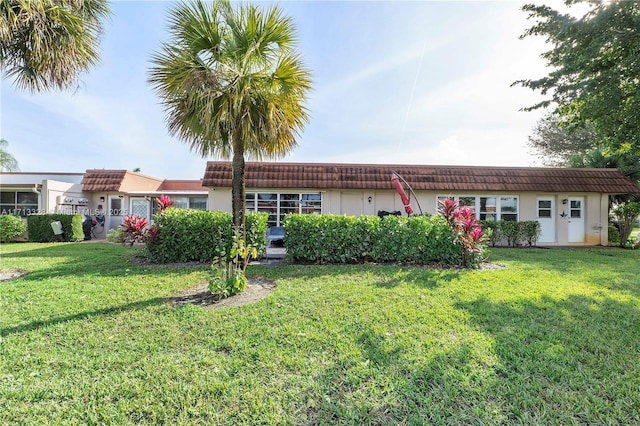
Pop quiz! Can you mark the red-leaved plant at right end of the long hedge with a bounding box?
[438,198,489,268]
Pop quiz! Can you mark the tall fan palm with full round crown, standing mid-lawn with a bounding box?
[149,0,311,239]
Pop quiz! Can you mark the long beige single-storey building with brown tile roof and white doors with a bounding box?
[203,162,640,246]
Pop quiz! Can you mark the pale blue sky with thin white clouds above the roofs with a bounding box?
[0,0,556,179]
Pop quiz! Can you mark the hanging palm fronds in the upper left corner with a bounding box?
[0,0,109,92]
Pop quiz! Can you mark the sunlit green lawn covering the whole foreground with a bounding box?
[0,243,640,425]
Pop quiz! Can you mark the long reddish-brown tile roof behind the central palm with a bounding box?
[203,161,640,194]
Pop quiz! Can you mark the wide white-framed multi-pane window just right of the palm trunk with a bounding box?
[245,192,322,226]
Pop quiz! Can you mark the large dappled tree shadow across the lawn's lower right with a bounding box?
[302,295,640,424]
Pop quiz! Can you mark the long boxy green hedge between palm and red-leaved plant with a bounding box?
[284,214,462,264]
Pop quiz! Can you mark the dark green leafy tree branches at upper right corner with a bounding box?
[514,0,640,155]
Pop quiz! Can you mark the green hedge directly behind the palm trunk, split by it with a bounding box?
[146,208,268,263]
